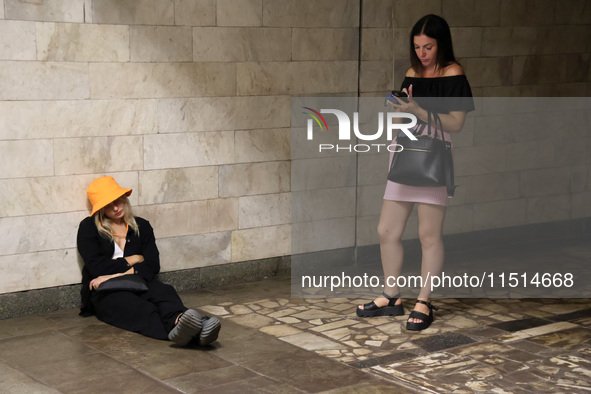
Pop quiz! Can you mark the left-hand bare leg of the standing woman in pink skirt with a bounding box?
[359,200,414,309]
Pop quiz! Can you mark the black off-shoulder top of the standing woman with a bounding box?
[400,75,475,113]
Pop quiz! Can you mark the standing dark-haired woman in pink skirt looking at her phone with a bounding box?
[357,15,474,331]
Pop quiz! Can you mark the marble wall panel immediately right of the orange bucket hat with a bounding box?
[139,167,218,205]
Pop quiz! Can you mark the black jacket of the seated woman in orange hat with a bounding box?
[76,216,160,315]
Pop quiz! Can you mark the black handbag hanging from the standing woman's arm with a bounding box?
[388,112,456,198]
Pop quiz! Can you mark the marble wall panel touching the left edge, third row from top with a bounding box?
[0,61,89,100]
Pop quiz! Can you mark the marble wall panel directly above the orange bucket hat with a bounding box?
[54,136,143,175]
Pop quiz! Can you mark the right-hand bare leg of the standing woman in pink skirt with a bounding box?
[409,203,446,323]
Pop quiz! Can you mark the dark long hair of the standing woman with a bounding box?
[410,14,457,75]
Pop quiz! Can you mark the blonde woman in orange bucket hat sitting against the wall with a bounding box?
[77,176,220,346]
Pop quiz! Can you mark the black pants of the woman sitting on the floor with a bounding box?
[90,280,187,339]
